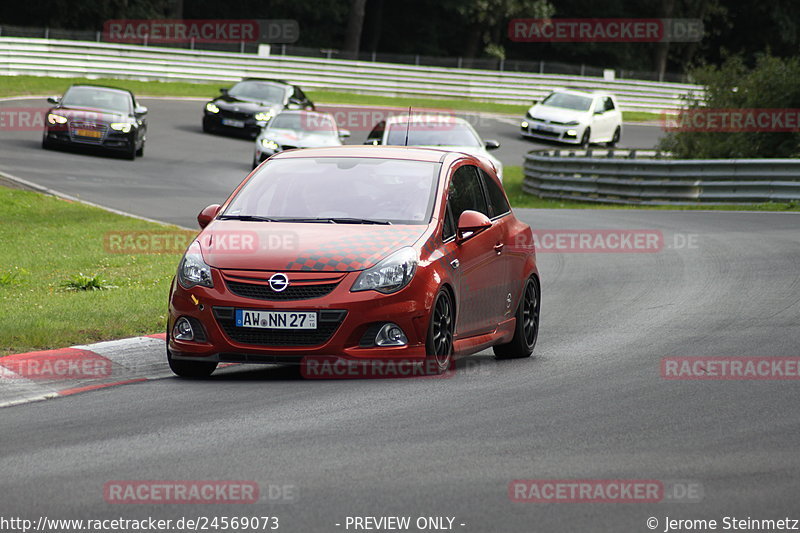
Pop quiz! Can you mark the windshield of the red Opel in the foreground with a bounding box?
[223,157,440,224]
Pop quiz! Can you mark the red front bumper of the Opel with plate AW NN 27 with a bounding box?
[167,270,430,363]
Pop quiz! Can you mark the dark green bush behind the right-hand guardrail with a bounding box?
[658,55,800,159]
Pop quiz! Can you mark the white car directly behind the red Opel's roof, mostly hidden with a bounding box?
[364,114,503,181]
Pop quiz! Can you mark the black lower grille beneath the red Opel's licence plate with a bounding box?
[214,307,347,346]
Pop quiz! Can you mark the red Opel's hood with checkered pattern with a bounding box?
[198,220,427,272]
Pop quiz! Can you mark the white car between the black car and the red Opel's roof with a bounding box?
[253,111,350,168]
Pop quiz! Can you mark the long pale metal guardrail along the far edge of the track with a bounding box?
[0,37,700,112]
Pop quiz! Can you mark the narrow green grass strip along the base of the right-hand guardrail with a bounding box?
[503,166,800,211]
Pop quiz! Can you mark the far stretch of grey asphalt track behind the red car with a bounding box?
[0,98,662,228]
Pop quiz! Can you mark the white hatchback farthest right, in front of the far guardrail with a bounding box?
[520,89,622,146]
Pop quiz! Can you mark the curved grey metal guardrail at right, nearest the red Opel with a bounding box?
[522,150,800,205]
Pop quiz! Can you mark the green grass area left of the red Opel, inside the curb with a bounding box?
[0,187,195,355]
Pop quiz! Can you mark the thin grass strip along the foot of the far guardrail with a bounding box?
[0,76,660,122]
